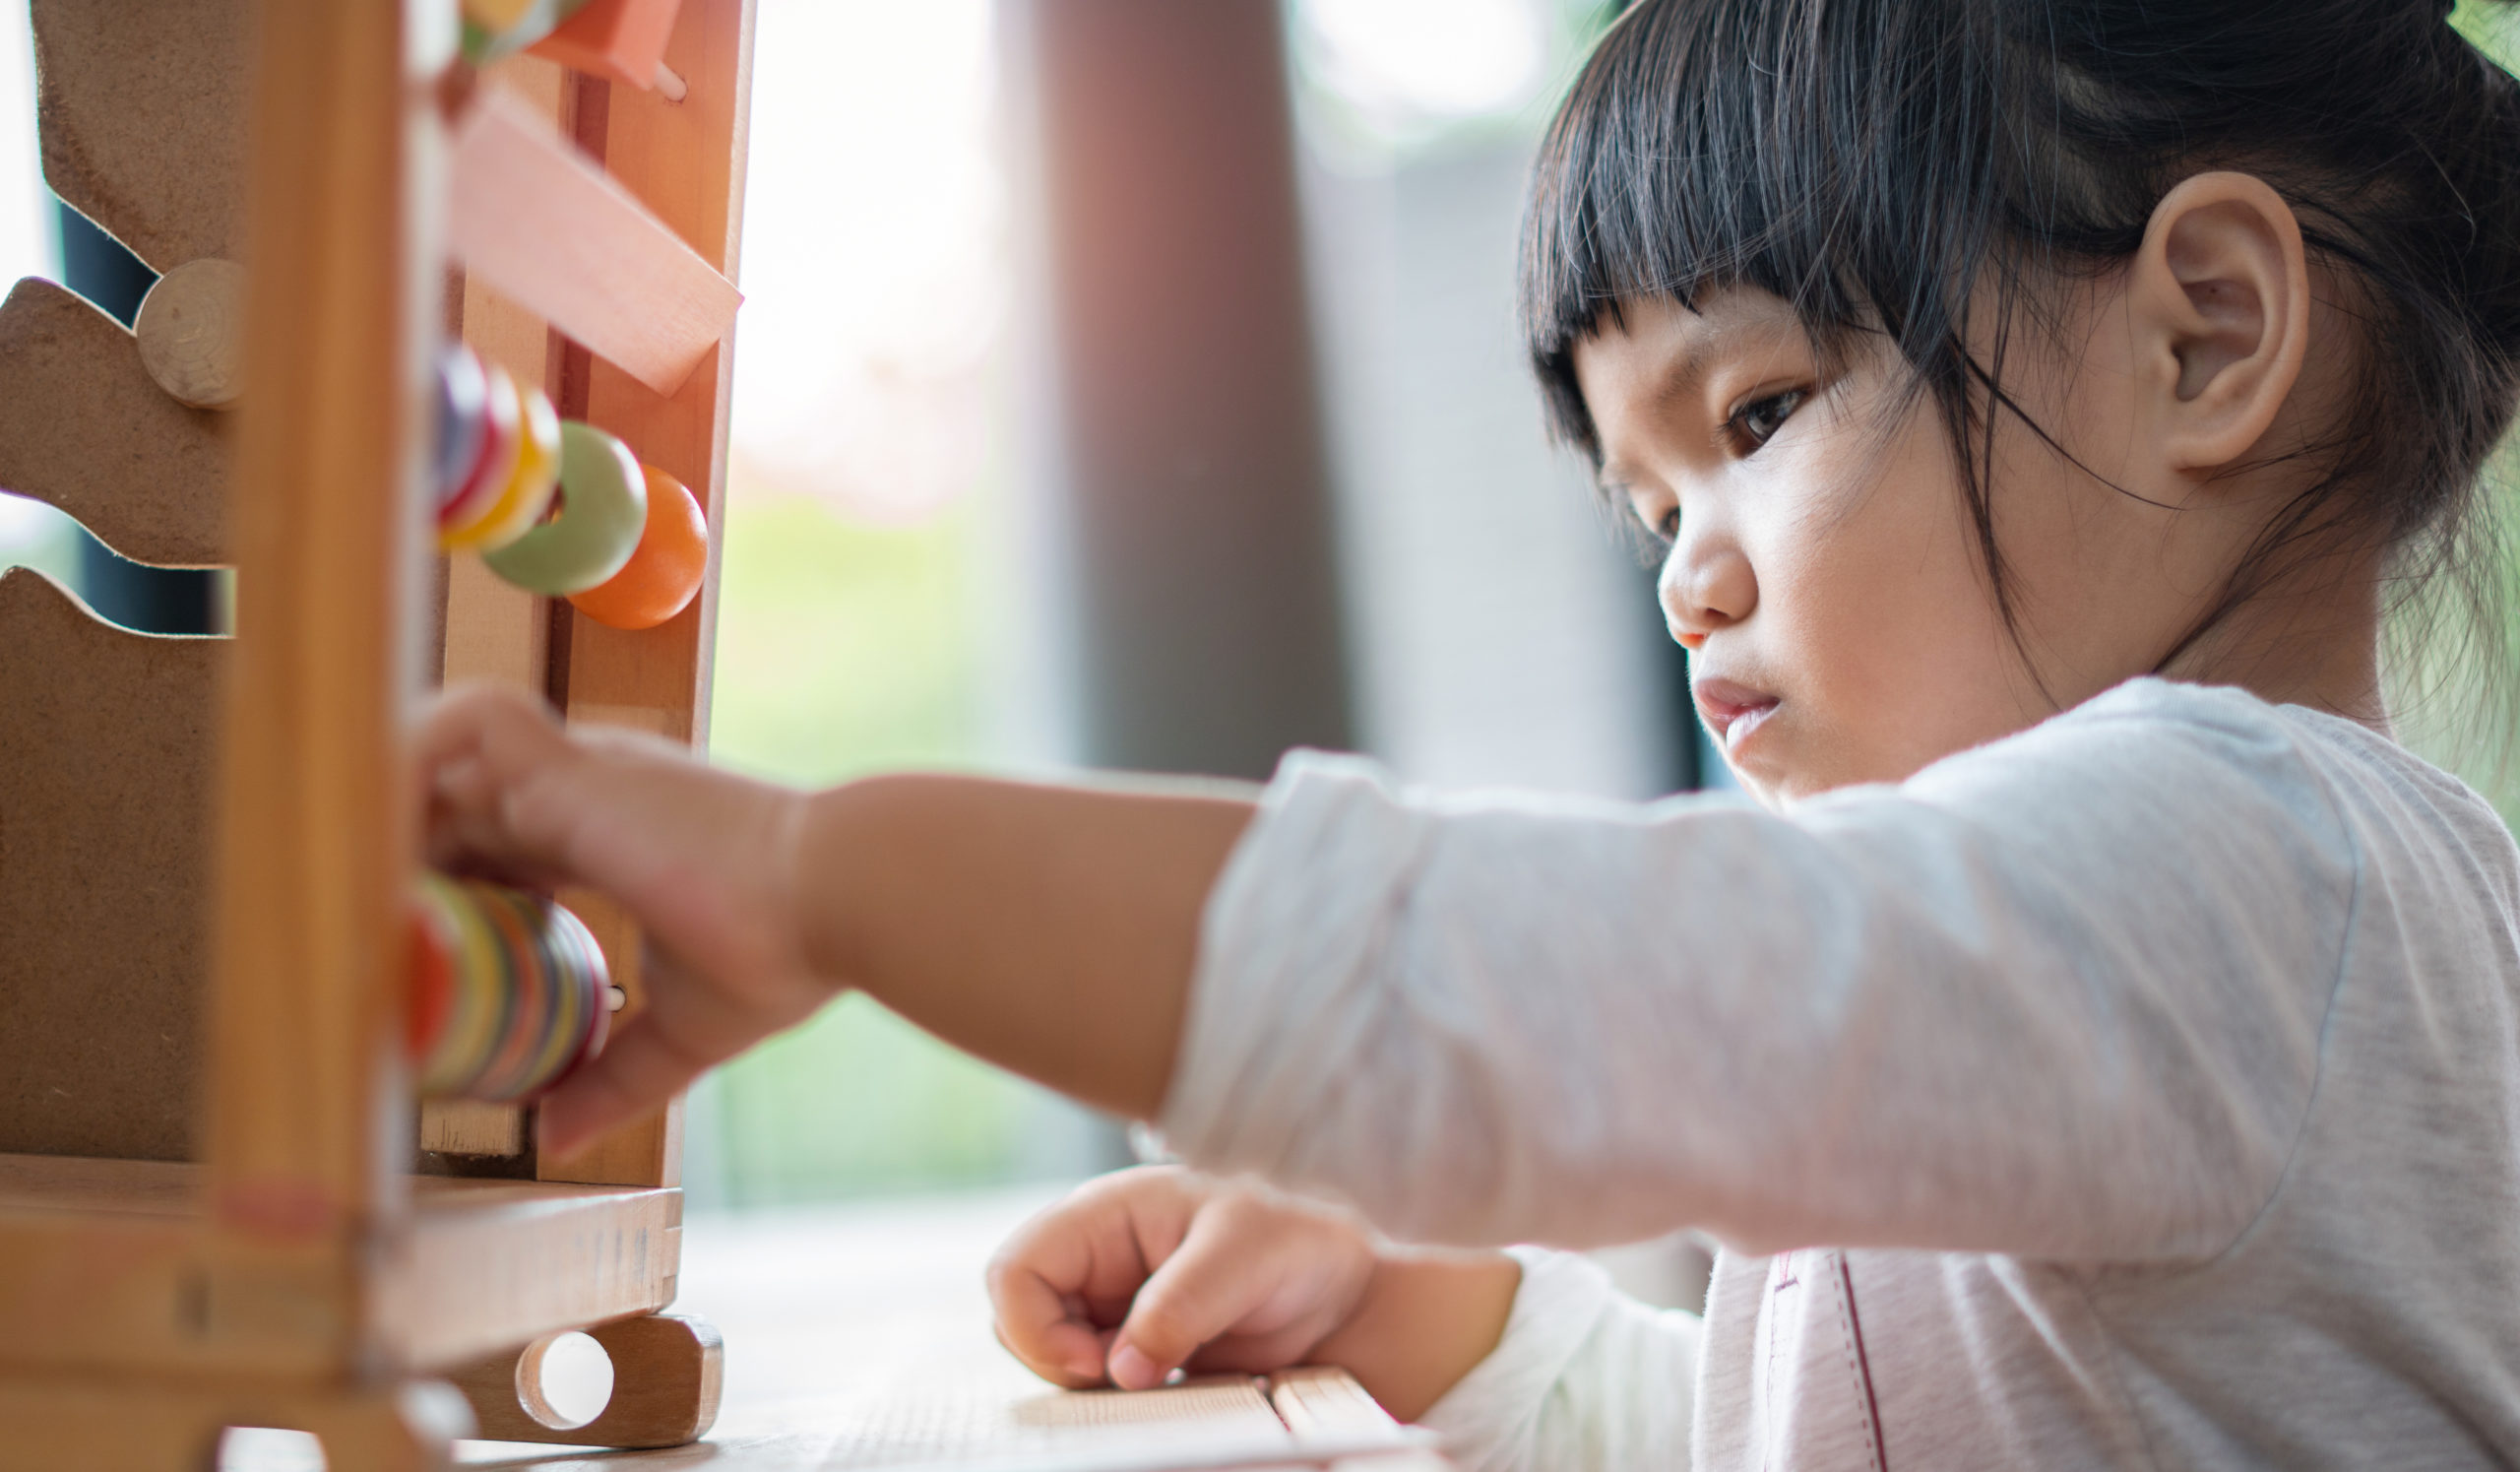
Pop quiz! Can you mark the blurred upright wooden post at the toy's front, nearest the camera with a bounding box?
[207,0,428,1320]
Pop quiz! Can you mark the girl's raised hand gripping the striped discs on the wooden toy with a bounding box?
[418,688,837,1154]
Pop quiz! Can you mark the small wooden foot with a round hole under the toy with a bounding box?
[454,1313,725,1446]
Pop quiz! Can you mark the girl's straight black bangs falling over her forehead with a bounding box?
[1522,0,2006,464]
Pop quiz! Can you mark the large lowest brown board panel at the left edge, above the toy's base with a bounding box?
[0,570,229,1160]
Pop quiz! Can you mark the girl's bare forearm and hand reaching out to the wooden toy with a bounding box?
[418,688,1252,1154]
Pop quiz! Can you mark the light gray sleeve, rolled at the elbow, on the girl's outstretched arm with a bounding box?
[1162,683,2354,1260]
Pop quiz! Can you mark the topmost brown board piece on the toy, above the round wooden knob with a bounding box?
[32,0,252,272]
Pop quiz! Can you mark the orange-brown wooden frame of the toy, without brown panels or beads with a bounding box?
[0,0,751,1472]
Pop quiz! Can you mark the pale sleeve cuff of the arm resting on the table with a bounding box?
[1421,1248,1704,1472]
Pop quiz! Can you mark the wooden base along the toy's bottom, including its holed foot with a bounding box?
[0,1154,721,1472]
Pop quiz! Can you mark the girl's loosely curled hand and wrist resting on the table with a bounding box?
[988,1167,1522,1419]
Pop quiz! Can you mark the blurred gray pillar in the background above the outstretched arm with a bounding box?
[1000,0,1354,776]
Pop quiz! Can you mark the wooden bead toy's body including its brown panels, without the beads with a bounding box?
[0,0,751,1472]
